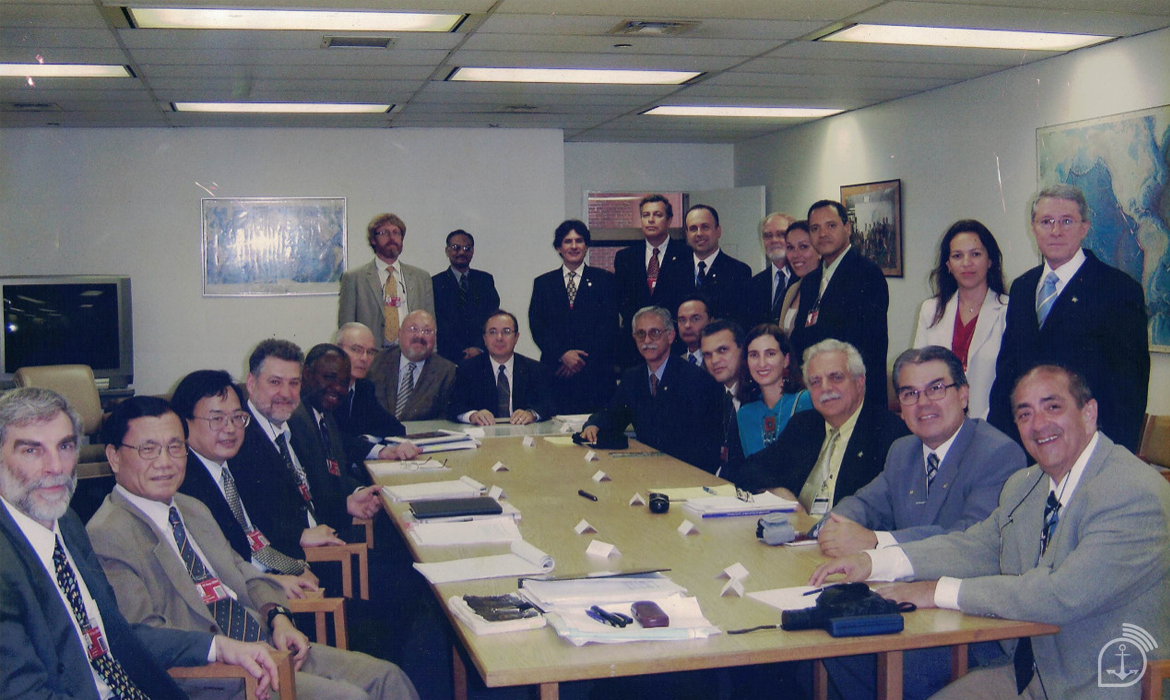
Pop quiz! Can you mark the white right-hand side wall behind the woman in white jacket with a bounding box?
[736,29,1170,413]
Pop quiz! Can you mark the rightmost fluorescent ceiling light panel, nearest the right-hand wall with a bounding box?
[819,25,1114,52]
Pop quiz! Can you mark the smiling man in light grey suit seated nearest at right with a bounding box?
[810,365,1170,700]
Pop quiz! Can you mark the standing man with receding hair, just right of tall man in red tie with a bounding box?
[683,204,751,324]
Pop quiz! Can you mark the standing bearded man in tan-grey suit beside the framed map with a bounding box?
[337,214,435,346]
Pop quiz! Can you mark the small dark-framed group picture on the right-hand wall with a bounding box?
[841,180,902,277]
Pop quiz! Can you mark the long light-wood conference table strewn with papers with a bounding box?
[376,421,1059,700]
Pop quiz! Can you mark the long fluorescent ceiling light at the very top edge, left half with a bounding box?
[126,7,458,32]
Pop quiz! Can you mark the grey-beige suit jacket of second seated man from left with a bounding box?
[85,490,288,646]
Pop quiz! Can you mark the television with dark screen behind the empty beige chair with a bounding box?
[0,275,135,389]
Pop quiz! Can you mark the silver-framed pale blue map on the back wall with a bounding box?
[201,197,345,296]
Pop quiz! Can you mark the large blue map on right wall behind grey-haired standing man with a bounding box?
[1035,105,1170,352]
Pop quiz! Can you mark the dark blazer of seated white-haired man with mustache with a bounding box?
[724,400,910,498]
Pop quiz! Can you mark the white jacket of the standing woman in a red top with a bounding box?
[914,289,1007,419]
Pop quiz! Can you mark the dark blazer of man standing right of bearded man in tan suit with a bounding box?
[431,267,500,364]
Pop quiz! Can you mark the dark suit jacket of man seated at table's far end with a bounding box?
[447,352,557,420]
